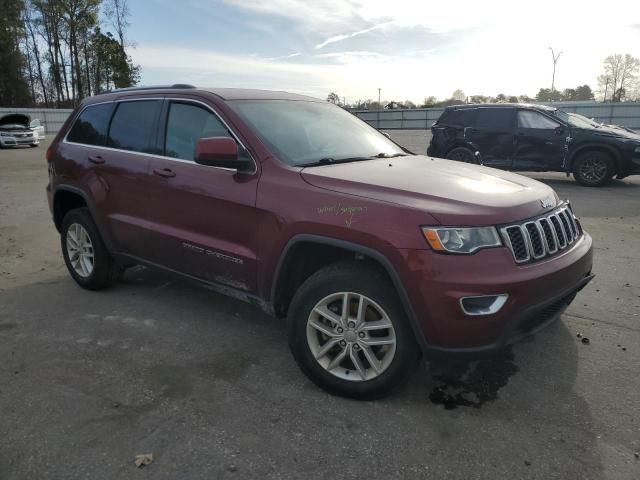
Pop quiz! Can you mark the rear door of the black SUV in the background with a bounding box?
[465,107,515,168]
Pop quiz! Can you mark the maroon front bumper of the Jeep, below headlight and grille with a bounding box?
[403,234,593,355]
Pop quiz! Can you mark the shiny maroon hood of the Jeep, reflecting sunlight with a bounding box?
[301,155,558,226]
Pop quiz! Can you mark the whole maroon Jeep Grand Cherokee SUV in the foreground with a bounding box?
[47,85,592,398]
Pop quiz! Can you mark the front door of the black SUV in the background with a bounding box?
[513,109,567,170]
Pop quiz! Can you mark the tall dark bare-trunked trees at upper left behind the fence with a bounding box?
[0,0,140,107]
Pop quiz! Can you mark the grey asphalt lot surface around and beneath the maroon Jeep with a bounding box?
[0,139,640,480]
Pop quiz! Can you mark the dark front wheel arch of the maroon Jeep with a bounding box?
[270,234,427,350]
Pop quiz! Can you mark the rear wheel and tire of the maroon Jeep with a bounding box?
[60,207,122,290]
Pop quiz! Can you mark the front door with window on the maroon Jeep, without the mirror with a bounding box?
[144,99,259,292]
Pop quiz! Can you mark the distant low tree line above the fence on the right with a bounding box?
[327,54,640,110]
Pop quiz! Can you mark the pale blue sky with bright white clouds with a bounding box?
[129,0,640,103]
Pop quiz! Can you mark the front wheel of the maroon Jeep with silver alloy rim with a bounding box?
[289,261,420,400]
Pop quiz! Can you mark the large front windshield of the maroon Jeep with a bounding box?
[229,100,404,166]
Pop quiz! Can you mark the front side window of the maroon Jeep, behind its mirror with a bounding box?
[165,103,231,160]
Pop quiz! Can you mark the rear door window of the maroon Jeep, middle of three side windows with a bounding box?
[107,100,161,152]
